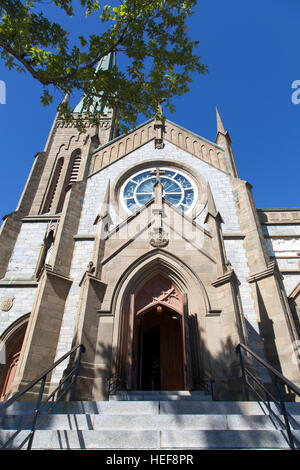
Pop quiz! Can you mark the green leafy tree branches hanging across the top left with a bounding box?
[0,0,207,130]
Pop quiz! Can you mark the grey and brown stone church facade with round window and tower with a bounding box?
[0,73,300,400]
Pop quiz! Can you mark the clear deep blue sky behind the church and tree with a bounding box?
[0,0,300,218]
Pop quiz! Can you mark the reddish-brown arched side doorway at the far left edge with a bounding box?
[0,315,28,401]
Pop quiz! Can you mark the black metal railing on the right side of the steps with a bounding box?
[236,344,300,450]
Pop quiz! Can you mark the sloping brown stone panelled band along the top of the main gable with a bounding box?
[91,119,229,173]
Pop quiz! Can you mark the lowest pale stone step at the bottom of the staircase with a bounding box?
[0,430,300,450]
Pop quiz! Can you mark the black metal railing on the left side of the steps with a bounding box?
[0,344,85,450]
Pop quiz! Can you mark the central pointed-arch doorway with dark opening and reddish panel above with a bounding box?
[129,275,186,390]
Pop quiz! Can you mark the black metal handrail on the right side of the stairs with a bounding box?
[236,343,300,450]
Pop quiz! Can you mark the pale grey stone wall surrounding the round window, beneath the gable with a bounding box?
[79,141,240,237]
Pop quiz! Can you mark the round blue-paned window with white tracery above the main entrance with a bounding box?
[121,168,197,213]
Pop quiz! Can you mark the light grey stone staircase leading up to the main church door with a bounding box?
[0,391,300,450]
